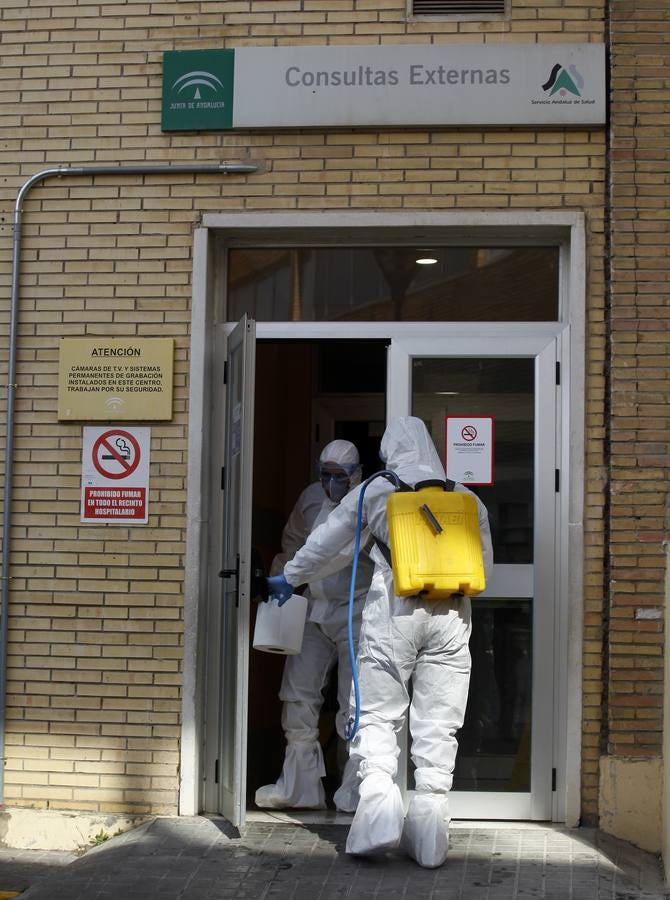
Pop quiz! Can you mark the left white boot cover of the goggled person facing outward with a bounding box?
[254,742,326,809]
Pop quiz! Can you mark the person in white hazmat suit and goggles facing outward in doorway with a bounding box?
[255,440,373,812]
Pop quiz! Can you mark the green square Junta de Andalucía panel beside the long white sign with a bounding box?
[161,50,235,131]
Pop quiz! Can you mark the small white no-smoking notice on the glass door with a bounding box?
[444,416,493,485]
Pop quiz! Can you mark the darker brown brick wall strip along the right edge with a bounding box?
[603,0,670,757]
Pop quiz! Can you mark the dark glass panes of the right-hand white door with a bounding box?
[411,357,535,792]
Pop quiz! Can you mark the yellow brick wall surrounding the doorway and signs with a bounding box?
[0,0,605,814]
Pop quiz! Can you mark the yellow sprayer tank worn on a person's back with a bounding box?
[377,480,486,600]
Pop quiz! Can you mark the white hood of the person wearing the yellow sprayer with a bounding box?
[379,416,445,485]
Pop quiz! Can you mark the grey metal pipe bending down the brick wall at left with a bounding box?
[0,163,260,804]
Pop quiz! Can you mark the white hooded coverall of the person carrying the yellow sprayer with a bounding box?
[284,416,493,867]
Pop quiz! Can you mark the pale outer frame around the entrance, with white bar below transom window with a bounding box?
[179,211,586,825]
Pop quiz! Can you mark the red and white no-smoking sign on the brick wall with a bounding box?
[81,425,151,525]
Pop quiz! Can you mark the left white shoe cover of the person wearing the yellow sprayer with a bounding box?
[346,772,404,856]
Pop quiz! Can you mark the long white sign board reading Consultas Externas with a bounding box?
[231,43,606,128]
